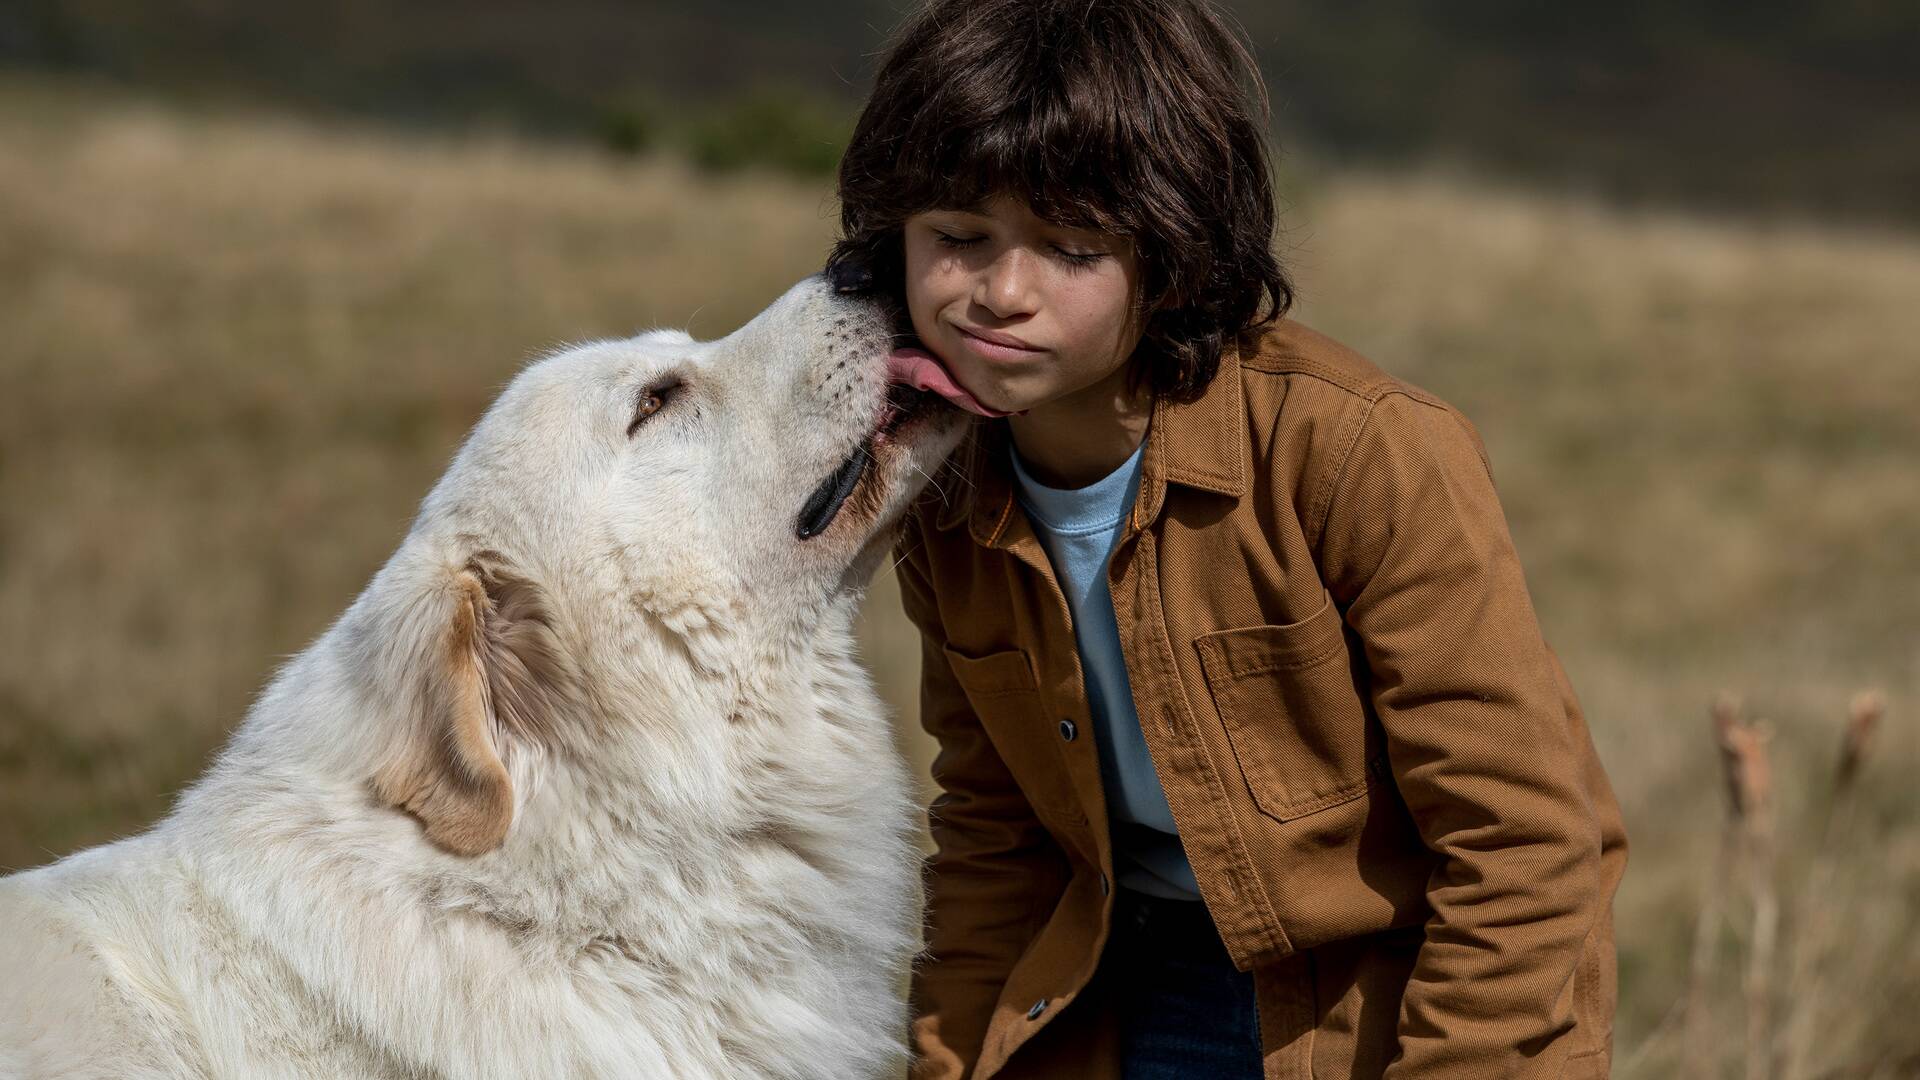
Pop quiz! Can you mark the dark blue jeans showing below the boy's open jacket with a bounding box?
[1094,890,1261,1080]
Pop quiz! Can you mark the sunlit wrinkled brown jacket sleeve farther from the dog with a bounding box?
[1321,390,1607,1078]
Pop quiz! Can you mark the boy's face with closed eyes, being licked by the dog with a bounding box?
[904,196,1140,411]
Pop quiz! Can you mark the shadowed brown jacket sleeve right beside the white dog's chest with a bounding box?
[895,519,1066,1080]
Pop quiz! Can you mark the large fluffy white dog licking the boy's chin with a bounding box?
[0,279,964,1080]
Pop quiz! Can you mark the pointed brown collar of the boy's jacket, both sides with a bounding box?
[935,342,1246,548]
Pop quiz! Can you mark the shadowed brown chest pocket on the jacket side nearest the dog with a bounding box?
[941,646,1087,824]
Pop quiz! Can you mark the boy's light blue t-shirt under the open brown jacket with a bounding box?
[1012,440,1200,899]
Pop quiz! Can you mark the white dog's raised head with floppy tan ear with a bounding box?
[337,279,966,853]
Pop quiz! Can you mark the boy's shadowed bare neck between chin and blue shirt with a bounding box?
[1006,365,1154,488]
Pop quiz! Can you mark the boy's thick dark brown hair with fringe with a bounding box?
[828,0,1294,398]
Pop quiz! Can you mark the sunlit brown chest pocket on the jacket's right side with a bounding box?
[1194,596,1369,821]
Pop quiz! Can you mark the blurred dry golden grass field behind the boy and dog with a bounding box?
[0,85,1920,1076]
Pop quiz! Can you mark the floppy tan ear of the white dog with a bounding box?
[374,553,574,855]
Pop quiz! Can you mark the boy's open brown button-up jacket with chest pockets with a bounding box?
[899,321,1626,1080]
